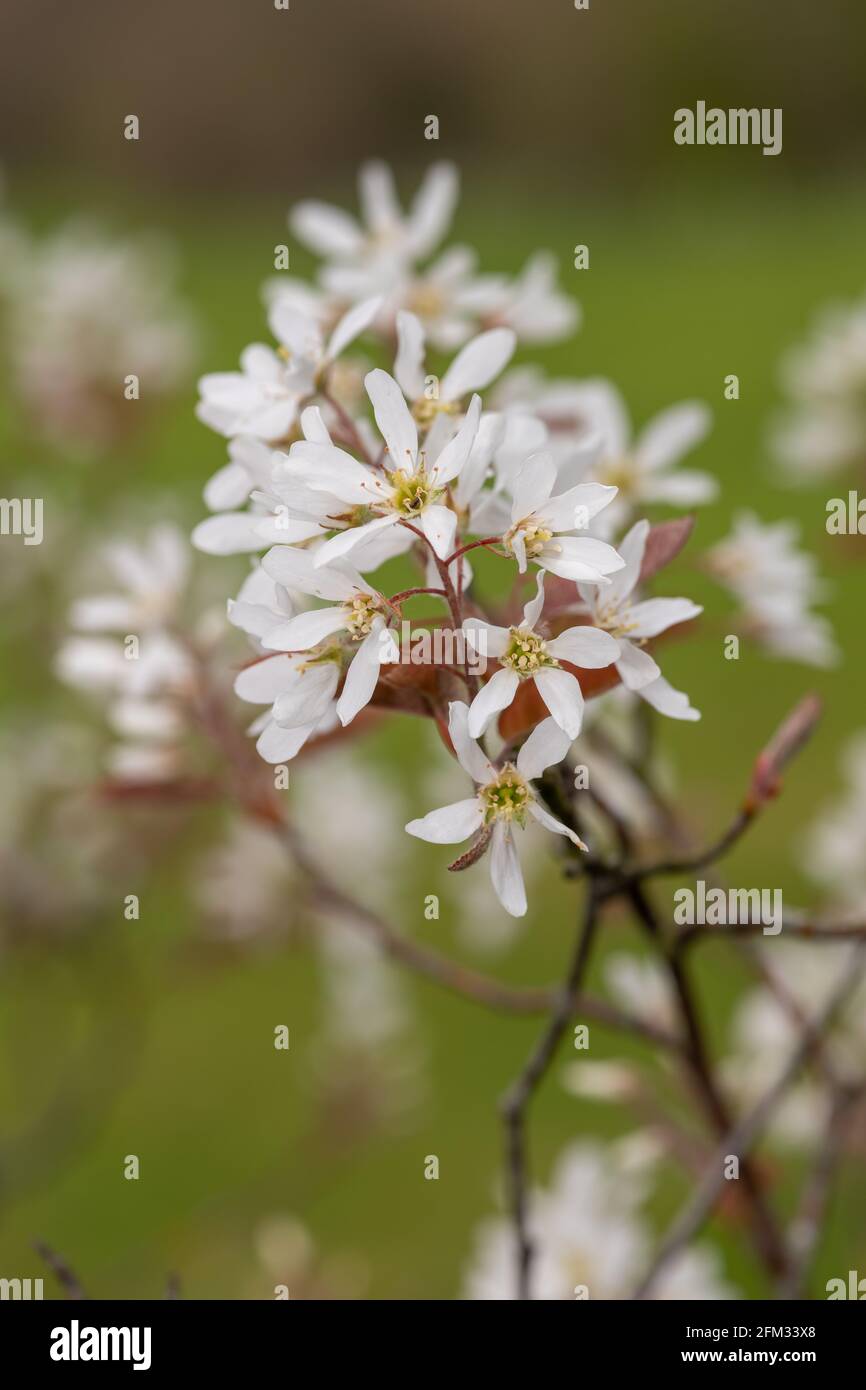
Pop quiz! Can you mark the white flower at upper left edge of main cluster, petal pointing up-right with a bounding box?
[196,299,379,442]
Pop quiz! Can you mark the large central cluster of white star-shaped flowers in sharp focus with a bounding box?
[193,164,714,915]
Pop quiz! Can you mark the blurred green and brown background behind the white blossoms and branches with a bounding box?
[0,0,866,1298]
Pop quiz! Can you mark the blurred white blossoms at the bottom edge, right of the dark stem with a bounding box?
[466,1143,734,1301]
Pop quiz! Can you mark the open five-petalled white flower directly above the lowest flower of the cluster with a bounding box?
[463,571,620,739]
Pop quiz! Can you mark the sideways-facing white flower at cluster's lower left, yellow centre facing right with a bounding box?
[255,545,399,724]
